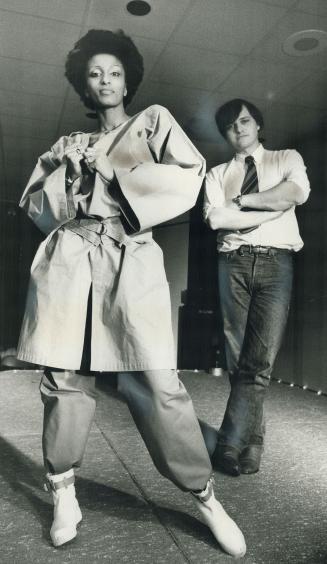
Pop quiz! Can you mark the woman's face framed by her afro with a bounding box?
[86,53,127,108]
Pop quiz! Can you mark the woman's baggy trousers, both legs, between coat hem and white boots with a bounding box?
[40,368,216,491]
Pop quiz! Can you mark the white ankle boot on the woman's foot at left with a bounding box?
[46,469,82,546]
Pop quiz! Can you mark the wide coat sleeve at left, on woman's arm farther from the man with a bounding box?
[19,133,88,234]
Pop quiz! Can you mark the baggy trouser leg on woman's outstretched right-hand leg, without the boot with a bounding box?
[118,370,212,491]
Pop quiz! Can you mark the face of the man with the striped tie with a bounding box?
[226,106,260,154]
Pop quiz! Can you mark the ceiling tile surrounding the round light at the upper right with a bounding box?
[251,11,327,68]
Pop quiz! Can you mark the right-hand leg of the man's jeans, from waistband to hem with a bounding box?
[218,252,292,472]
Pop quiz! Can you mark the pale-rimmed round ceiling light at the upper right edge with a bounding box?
[283,29,327,57]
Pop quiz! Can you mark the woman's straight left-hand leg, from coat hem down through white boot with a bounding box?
[40,369,96,546]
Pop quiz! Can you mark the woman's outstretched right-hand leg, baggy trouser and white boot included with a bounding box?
[118,370,246,556]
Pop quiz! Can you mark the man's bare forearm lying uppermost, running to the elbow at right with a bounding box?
[241,180,307,211]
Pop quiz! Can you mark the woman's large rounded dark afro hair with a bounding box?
[65,29,144,110]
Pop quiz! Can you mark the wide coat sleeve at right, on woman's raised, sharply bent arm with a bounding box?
[115,106,205,231]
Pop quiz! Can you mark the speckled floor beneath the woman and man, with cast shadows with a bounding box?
[0,370,327,564]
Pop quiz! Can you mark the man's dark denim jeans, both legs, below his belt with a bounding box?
[218,247,293,451]
